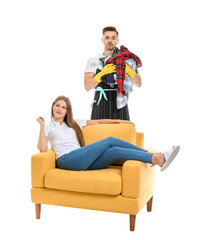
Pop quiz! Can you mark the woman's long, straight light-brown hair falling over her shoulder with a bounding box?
[51,96,85,147]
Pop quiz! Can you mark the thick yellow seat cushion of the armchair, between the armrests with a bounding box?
[45,166,122,195]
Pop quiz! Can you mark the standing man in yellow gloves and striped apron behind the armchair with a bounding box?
[84,27,141,121]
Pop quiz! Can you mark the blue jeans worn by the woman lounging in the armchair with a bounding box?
[57,137,153,171]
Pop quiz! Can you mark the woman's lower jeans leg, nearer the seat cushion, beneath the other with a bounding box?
[88,147,154,170]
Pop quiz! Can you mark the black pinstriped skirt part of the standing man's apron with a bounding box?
[91,82,130,121]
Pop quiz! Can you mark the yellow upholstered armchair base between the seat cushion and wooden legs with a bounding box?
[31,185,154,215]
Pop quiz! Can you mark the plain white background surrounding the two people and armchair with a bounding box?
[0,0,199,239]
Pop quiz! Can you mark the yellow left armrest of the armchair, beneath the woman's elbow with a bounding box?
[31,149,55,187]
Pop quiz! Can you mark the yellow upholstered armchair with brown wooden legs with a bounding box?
[31,124,155,231]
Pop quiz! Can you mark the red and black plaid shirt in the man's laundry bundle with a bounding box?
[106,45,142,96]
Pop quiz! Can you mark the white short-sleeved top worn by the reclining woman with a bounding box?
[44,119,87,159]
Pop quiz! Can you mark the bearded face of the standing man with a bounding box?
[102,31,119,51]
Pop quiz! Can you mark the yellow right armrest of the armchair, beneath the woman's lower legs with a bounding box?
[122,160,155,198]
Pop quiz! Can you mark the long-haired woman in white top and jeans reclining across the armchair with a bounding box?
[37,96,180,171]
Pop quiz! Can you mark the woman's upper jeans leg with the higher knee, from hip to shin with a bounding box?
[57,137,147,171]
